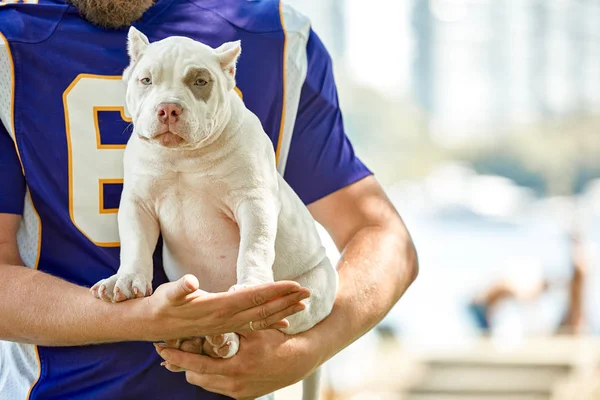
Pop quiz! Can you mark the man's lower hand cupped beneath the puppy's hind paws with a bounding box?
[155,329,320,399]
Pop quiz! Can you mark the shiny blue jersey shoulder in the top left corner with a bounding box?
[0,0,68,43]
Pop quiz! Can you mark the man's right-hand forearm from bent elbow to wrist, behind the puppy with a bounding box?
[306,224,418,362]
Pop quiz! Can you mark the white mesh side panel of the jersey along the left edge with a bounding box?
[0,34,41,400]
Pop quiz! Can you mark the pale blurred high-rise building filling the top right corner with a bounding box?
[420,0,600,144]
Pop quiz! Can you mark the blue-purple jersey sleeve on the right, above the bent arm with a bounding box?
[284,29,371,204]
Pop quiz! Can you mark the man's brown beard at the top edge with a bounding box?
[69,0,154,29]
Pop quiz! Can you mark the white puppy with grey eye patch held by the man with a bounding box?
[93,28,337,398]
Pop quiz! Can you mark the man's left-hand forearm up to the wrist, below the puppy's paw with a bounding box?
[0,265,145,346]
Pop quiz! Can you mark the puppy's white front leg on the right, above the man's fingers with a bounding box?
[235,195,280,286]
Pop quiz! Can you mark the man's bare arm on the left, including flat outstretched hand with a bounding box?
[0,214,307,346]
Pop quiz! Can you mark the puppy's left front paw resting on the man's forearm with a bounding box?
[90,274,152,303]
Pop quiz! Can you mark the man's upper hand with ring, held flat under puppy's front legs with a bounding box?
[142,275,310,340]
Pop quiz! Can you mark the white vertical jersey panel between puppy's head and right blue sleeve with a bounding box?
[277,3,310,175]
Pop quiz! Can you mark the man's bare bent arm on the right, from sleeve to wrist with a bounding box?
[305,176,418,364]
